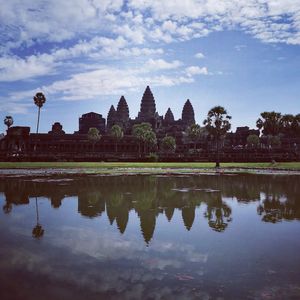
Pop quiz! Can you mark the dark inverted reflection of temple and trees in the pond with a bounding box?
[0,175,300,244]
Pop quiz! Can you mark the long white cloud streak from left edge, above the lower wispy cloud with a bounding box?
[0,36,164,82]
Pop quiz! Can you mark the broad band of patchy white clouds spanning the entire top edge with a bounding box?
[0,0,300,56]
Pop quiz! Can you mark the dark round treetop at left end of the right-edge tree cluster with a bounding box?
[256,111,281,135]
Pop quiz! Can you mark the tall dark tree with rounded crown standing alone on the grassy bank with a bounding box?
[203,106,231,168]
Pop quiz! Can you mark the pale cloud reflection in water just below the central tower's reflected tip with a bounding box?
[44,227,208,270]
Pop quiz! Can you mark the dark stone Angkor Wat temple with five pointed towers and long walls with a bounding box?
[0,86,300,161]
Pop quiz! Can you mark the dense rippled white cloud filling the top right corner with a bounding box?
[129,0,300,44]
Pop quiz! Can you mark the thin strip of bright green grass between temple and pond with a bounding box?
[0,162,300,170]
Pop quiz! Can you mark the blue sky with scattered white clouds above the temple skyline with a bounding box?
[0,0,300,133]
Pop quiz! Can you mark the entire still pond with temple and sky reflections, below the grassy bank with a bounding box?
[0,175,300,300]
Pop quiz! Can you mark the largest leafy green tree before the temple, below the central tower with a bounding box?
[132,123,157,155]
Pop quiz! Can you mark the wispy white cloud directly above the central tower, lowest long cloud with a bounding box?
[7,60,197,101]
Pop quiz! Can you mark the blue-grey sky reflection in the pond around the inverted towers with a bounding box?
[0,179,300,299]
